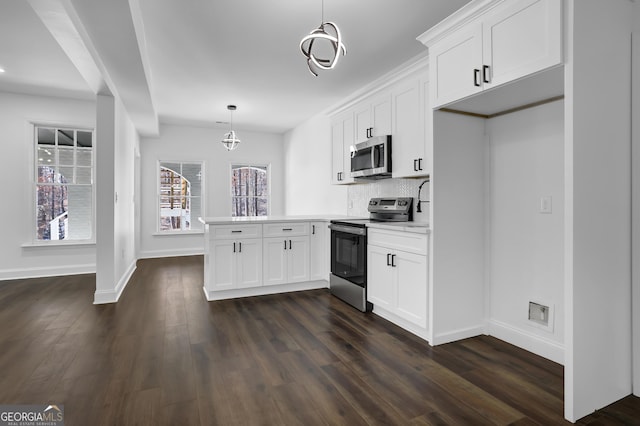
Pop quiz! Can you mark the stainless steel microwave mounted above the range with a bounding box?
[351,135,391,179]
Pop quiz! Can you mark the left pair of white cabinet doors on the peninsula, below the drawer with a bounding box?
[209,238,262,290]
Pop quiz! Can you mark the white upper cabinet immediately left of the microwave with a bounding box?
[331,111,354,185]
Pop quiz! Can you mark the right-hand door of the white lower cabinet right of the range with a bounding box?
[393,251,428,327]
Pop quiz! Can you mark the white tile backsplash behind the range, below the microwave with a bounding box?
[347,179,431,222]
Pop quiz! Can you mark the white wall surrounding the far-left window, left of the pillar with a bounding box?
[0,92,96,280]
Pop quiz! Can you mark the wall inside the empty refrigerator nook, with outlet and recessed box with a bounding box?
[486,101,564,363]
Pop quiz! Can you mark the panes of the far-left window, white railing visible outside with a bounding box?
[35,126,94,241]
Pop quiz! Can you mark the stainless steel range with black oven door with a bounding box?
[329,197,413,312]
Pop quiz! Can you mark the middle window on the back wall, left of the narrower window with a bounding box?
[158,161,203,232]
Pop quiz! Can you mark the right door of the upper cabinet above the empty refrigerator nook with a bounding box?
[482,0,562,88]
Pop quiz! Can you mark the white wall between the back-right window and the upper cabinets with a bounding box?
[284,115,347,215]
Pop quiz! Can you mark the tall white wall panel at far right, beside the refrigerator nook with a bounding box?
[565,0,633,421]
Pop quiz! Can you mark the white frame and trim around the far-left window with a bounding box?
[30,121,97,247]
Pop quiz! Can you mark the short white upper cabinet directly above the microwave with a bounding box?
[354,92,392,143]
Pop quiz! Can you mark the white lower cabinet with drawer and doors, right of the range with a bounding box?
[367,229,429,329]
